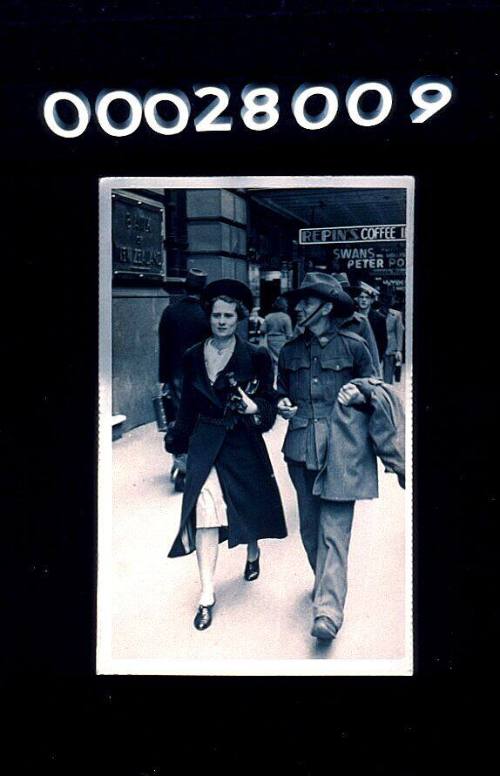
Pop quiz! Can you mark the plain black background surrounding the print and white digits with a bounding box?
[0,0,500,776]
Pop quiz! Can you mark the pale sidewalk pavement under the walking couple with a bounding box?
[108,372,405,673]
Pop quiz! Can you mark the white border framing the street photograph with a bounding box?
[96,175,415,676]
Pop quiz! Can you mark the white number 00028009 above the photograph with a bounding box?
[43,77,453,138]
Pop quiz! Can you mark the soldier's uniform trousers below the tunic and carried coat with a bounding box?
[288,461,354,629]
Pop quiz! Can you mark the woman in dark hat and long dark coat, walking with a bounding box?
[165,279,287,630]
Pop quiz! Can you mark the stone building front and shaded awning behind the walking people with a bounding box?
[112,188,406,431]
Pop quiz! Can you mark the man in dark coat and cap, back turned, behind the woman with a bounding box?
[158,268,210,484]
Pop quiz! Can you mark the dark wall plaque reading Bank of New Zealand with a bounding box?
[113,194,165,280]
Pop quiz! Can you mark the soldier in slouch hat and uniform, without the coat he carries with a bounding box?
[278,272,375,641]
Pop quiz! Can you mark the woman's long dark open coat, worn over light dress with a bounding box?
[165,337,287,557]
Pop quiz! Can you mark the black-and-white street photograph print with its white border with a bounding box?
[97,176,414,675]
